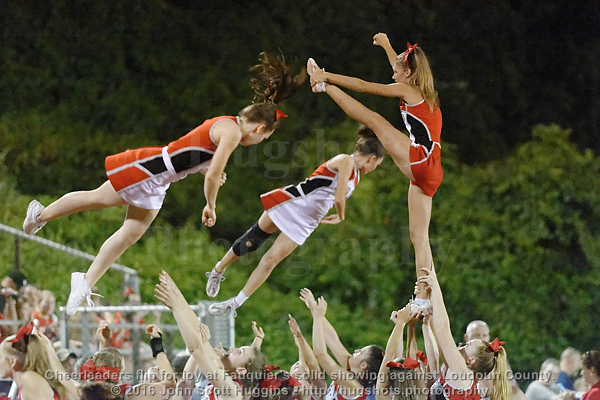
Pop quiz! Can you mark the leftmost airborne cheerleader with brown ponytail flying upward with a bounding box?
[23,53,306,316]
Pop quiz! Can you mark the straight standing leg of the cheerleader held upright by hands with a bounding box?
[408,185,433,299]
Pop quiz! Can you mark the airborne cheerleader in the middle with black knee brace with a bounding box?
[206,126,385,315]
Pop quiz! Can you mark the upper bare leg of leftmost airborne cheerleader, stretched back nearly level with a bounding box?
[38,181,127,222]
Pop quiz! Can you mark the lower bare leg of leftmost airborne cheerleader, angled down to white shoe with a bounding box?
[85,204,160,287]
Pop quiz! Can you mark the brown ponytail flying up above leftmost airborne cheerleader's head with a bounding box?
[250,51,307,103]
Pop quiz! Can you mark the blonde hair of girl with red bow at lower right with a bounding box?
[469,339,512,400]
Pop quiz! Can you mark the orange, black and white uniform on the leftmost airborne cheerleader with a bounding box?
[105,116,239,210]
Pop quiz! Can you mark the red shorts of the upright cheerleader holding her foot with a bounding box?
[409,144,444,197]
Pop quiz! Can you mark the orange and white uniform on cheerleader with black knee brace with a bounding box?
[260,155,360,245]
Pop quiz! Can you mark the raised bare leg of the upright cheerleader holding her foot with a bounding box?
[325,85,414,181]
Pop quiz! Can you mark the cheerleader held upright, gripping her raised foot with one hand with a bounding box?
[308,33,443,313]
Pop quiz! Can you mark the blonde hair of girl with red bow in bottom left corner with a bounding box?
[2,335,67,399]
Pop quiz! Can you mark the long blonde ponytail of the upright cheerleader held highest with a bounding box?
[396,46,440,112]
